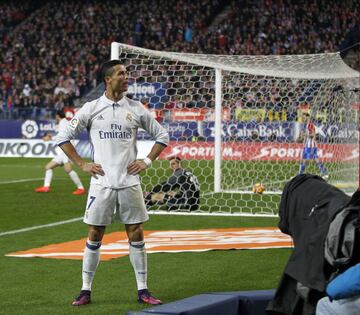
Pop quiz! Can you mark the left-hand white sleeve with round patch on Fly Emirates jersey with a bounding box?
[55,103,91,145]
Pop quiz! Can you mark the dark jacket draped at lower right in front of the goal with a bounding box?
[267,174,350,315]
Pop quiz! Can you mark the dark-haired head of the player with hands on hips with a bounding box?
[100,60,128,93]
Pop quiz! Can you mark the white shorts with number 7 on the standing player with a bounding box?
[84,185,149,226]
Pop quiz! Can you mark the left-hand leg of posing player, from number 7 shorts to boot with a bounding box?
[72,185,116,306]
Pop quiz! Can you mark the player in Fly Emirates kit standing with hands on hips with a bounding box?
[57,60,169,306]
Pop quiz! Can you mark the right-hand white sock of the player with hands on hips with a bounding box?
[129,241,147,290]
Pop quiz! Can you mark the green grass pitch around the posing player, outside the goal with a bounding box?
[0,158,291,315]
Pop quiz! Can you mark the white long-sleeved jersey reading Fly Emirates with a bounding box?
[57,94,169,188]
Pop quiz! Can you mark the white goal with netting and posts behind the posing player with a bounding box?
[111,43,360,215]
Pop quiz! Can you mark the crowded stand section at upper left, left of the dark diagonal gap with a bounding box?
[0,0,229,118]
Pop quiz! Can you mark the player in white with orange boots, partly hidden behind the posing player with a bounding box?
[35,110,86,195]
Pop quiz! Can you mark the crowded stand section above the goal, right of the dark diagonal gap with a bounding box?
[201,0,359,55]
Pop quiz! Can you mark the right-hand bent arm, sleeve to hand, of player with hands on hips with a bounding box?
[128,105,169,175]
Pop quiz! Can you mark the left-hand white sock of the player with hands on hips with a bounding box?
[81,240,101,291]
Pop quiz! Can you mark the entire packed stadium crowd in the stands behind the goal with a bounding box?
[0,0,360,118]
